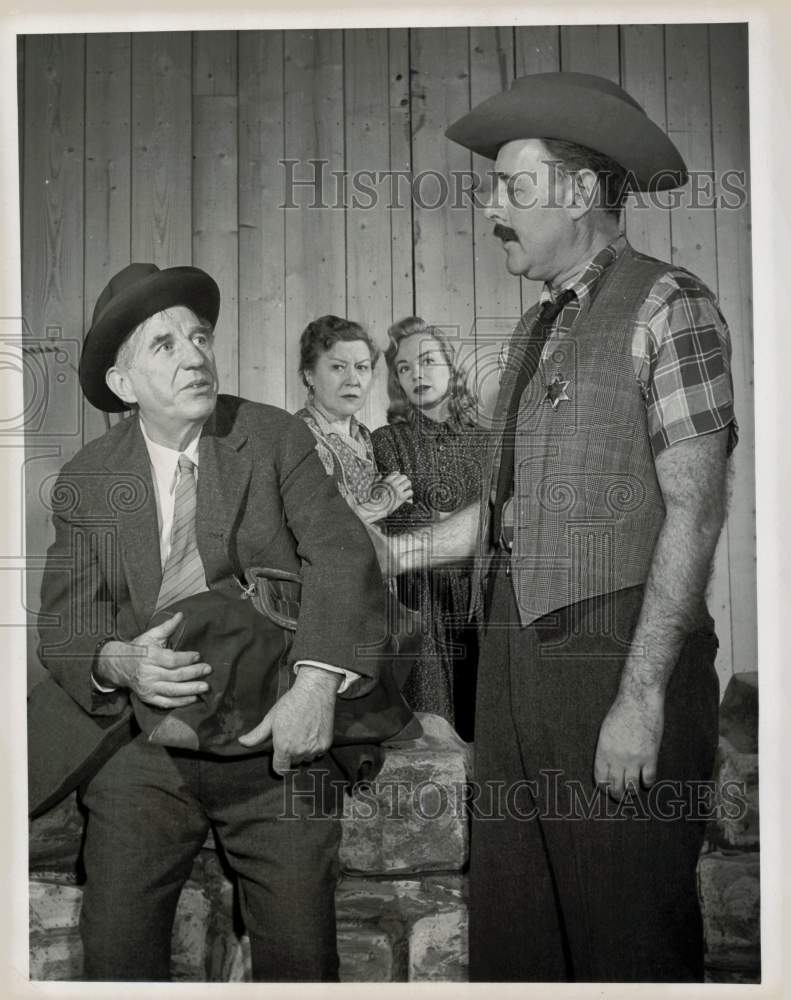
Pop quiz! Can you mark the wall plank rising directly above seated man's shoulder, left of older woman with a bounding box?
[239,31,286,406]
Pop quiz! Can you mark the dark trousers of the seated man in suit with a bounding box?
[80,736,344,982]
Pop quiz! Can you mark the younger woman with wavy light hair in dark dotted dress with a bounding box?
[372,316,483,741]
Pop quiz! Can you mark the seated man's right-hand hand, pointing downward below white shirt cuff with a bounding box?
[239,666,343,775]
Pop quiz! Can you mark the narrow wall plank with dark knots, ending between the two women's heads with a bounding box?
[387,28,415,340]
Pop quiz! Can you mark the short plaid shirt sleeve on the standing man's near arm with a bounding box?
[633,268,738,456]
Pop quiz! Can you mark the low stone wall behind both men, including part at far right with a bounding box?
[30,674,760,982]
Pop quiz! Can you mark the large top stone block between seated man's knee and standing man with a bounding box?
[340,713,471,875]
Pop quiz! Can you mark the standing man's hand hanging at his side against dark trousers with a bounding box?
[593,688,665,799]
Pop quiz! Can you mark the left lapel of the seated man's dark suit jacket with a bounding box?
[105,417,162,632]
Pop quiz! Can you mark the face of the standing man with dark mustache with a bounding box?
[485,139,573,281]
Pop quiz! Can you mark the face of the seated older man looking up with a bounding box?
[107,306,217,446]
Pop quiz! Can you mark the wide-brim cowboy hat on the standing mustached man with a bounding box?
[445,73,687,191]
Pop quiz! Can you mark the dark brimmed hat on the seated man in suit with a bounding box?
[80,264,220,413]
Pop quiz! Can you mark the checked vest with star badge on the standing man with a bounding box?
[474,246,669,625]
